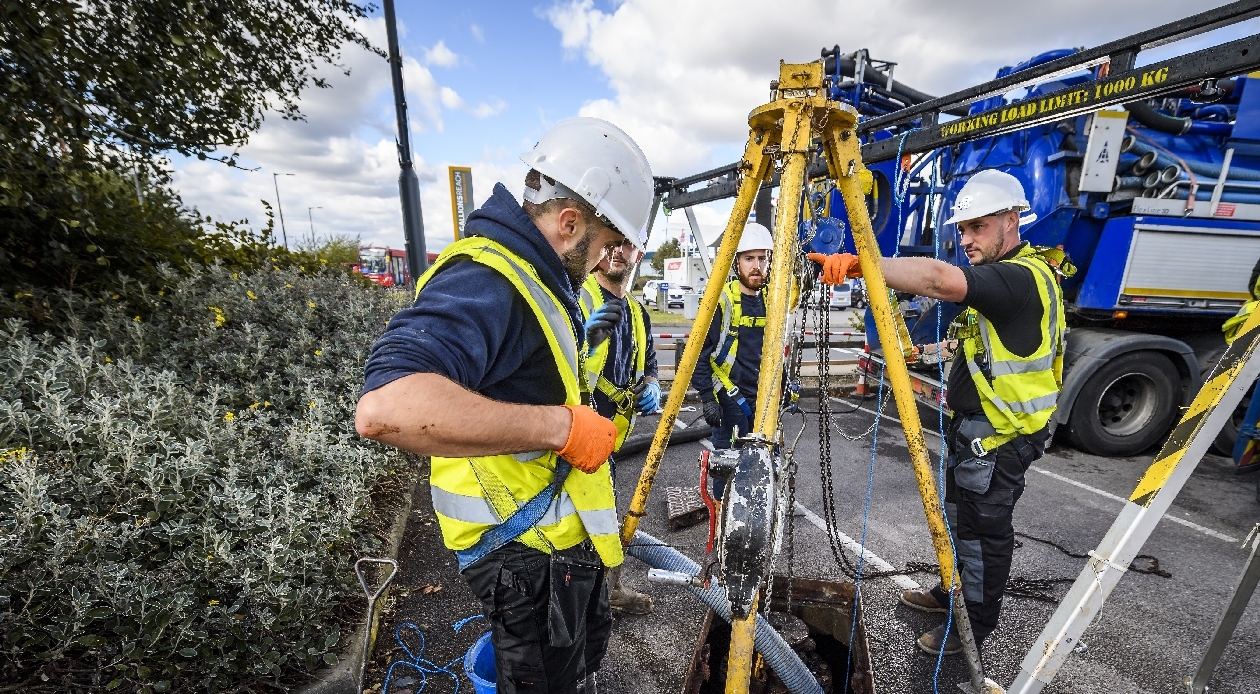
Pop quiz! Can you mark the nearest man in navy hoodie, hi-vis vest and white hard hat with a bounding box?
[355,118,653,694]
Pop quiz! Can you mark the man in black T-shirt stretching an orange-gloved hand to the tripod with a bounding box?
[810,170,1075,655]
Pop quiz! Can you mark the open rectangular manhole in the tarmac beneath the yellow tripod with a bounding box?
[683,577,874,694]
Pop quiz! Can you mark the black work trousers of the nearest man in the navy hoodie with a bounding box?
[464,542,612,694]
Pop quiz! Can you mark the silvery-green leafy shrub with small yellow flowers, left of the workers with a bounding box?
[0,267,408,691]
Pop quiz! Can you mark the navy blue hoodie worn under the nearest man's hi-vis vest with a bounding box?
[363,184,582,404]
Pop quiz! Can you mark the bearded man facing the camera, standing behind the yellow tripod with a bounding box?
[692,222,775,499]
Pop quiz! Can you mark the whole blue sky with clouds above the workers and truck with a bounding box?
[173,0,1260,258]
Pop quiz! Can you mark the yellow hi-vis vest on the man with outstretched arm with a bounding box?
[956,246,1076,451]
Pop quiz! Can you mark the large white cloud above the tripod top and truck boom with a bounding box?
[542,0,1249,175]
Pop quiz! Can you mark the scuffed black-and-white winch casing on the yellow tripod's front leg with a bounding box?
[709,442,776,618]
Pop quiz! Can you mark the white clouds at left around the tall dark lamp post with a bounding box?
[173,19,516,258]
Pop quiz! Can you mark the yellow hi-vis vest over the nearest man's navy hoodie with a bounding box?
[416,237,625,567]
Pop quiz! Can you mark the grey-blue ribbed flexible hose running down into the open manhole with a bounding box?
[626,530,823,694]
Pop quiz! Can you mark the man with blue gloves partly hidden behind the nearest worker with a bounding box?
[578,239,660,615]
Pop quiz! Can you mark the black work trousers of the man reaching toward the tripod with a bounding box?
[932,414,1050,644]
